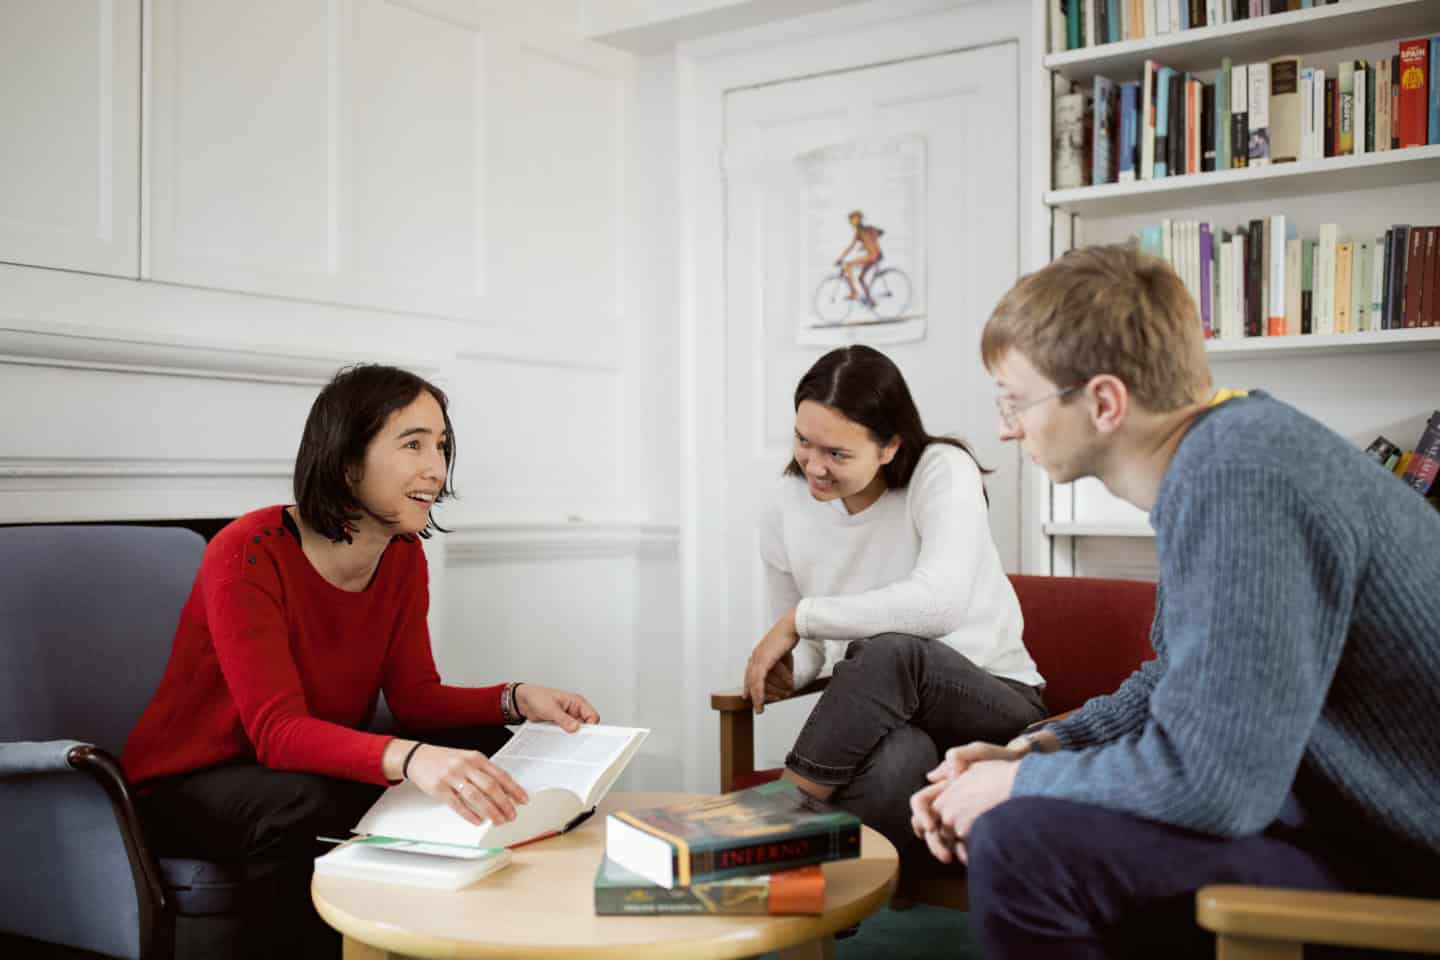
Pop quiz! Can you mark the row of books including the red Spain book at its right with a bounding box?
[1054,36,1440,190]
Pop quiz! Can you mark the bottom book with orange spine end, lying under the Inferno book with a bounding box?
[595,856,825,917]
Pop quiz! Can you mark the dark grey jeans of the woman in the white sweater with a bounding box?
[785,633,1045,851]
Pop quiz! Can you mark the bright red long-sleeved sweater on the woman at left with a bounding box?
[124,507,504,783]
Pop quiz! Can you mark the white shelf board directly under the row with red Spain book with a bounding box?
[1045,144,1440,216]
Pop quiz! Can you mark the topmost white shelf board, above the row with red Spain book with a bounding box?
[1041,0,1440,82]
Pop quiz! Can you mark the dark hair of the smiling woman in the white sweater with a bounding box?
[785,344,994,499]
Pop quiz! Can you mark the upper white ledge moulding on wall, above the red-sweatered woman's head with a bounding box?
[0,317,438,386]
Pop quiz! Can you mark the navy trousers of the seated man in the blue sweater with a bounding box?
[966,797,1440,960]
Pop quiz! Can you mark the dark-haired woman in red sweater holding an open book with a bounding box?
[124,366,599,938]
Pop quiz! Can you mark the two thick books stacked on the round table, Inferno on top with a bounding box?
[595,782,860,915]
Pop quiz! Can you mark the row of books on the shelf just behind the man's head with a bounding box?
[1139,214,1440,340]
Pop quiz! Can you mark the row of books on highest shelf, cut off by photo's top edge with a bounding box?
[1050,0,1339,53]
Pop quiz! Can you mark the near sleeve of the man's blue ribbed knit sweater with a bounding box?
[1014,463,1361,836]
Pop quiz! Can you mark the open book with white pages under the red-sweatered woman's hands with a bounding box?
[354,723,649,852]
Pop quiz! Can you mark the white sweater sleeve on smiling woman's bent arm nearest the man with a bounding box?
[795,445,995,652]
